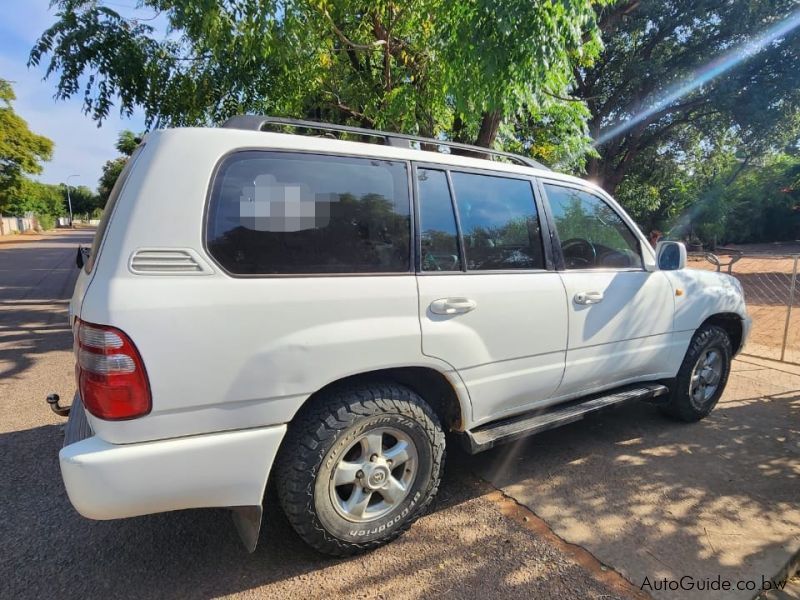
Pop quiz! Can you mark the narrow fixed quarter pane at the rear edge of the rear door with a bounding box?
[417,169,461,271]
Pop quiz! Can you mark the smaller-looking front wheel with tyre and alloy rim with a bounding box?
[663,325,733,422]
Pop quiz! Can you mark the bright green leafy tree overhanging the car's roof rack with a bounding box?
[30,0,607,160]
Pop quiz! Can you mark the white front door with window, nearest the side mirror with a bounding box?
[543,181,674,397]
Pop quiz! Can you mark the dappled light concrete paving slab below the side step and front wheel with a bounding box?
[473,390,800,597]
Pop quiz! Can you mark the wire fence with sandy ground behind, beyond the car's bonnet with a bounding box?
[688,254,800,364]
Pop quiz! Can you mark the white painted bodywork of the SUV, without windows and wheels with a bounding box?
[60,129,748,519]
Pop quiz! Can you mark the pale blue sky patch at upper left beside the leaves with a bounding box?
[0,0,152,189]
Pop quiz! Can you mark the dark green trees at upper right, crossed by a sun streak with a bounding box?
[575,0,800,243]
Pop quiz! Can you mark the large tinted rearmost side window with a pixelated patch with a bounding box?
[206,151,411,275]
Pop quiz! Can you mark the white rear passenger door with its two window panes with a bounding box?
[414,165,567,424]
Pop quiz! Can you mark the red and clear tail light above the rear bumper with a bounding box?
[75,319,152,420]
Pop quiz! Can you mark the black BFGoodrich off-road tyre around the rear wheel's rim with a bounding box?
[275,383,445,556]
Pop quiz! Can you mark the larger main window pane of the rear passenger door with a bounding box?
[452,172,544,271]
